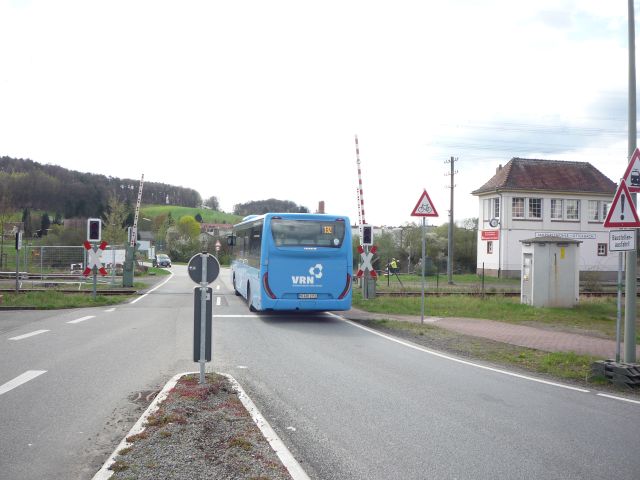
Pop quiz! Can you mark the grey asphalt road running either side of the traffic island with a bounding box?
[0,267,640,480]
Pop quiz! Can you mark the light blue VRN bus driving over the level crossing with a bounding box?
[229,213,353,311]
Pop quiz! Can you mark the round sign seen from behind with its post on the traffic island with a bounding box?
[187,252,220,385]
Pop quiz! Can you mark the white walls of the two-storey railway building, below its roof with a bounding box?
[477,192,618,276]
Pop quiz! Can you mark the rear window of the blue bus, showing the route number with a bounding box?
[271,218,345,248]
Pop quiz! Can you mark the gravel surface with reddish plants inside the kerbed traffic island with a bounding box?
[104,374,291,480]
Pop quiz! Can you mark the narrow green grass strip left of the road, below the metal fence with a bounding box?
[2,291,132,310]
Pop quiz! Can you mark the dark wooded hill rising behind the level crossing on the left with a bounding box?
[0,157,202,218]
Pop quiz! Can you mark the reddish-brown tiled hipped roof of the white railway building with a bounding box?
[471,158,617,195]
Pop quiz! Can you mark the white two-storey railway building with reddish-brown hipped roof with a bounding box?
[472,158,618,279]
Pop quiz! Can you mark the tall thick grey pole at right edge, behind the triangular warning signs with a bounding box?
[624,0,638,363]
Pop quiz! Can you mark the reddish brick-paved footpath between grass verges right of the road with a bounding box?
[343,308,640,358]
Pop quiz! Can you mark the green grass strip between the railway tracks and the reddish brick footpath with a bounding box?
[353,289,640,342]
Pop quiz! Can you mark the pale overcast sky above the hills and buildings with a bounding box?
[0,0,638,225]
